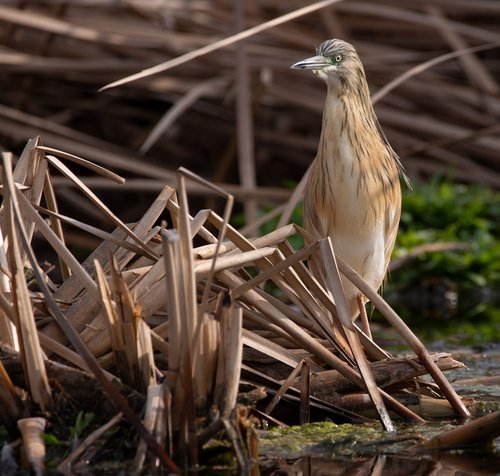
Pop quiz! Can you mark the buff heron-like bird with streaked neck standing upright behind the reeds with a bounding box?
[291,38,409,337]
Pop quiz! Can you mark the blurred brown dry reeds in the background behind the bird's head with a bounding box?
[0,0,500,236]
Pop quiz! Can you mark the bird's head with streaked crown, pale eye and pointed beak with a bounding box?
[291,38,365,86]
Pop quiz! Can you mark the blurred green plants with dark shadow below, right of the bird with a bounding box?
[385,177,500,344]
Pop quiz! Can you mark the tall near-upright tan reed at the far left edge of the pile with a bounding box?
[2,153,51,411]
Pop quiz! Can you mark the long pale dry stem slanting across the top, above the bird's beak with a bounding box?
[99,0,342,91]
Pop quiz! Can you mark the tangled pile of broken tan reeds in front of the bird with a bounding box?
[0,139,492,471]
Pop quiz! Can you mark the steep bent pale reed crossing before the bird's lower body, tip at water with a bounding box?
[320,237,394,431]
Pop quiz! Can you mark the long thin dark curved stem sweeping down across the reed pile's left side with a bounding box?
[9,206,179,473]
